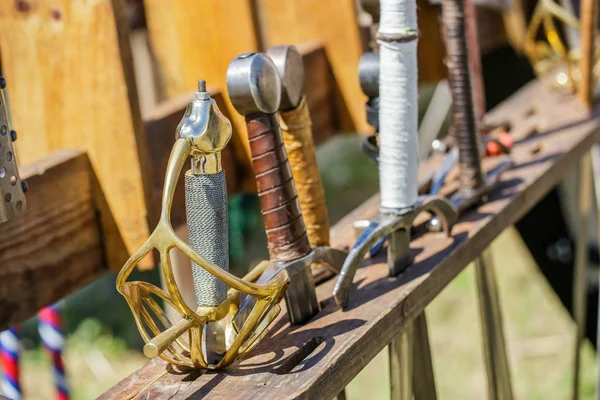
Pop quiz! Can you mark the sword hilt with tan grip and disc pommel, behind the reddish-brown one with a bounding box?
[267,46,347,280]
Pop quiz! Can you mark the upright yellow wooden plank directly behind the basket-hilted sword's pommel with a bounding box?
[144,0,258,191]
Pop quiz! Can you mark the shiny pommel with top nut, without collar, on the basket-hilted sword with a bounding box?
[176,80,232,155]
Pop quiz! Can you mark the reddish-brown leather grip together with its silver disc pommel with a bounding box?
[227,53,311,262]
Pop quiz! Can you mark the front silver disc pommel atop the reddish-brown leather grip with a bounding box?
[227,53,281,116]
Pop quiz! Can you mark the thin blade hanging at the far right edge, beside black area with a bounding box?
[572,153,592,399]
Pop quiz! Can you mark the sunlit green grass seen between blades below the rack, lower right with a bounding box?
[347,229,597,400]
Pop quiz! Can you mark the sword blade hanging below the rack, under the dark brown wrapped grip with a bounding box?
[475,249,513,400]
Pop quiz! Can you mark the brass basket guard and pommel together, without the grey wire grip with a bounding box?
[117,83,289,369]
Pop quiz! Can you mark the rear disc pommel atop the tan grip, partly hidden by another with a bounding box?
[267,46,304,111]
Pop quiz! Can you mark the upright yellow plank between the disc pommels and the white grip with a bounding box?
[257,0,372,132]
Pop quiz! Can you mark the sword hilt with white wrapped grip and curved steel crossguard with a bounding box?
[333,0,456,308]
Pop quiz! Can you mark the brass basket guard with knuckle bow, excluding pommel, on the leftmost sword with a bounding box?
[117,138,289,369]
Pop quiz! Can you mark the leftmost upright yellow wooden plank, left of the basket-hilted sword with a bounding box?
[0,0,148,267]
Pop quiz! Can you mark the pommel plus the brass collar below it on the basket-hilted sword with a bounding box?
[175,80,232,174]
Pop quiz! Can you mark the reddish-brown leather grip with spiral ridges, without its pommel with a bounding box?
[246,114,311,261]
